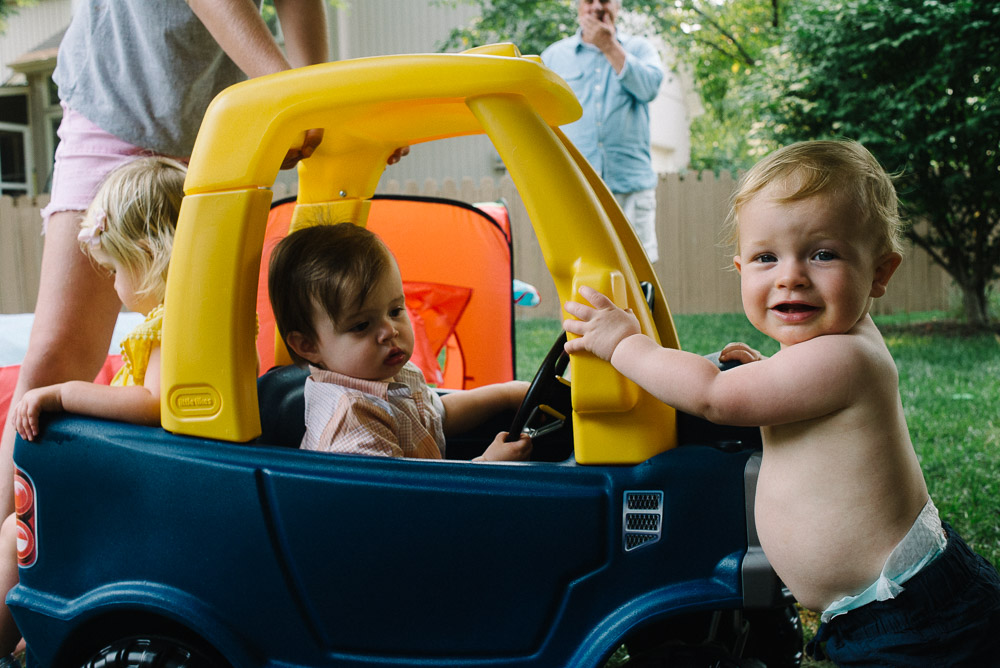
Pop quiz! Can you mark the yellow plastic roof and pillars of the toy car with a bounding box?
[161,45,677,463]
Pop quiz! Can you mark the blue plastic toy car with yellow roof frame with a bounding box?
[8,46,802,668]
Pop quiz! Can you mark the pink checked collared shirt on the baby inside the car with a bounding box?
[300,362,444,459]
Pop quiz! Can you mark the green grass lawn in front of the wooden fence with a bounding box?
[516,312,1000,668]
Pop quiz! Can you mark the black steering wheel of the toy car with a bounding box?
[507,332,572,441]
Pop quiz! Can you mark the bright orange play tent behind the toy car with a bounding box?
[257,196,514,389]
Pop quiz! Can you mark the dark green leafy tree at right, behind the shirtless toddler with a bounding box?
[747,0,1000,325]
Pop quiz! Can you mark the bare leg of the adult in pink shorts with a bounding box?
[0,211,121,517]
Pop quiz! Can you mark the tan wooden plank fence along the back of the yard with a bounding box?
[0,174,953,318]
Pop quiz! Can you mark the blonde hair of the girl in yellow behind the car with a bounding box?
[79,156,187,302]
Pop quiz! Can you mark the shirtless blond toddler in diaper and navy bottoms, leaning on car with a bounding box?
[564,141,1000,666]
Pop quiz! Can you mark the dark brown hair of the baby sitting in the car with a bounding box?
[267,223,395,364]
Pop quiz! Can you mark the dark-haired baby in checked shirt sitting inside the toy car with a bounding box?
[268,223,531,461]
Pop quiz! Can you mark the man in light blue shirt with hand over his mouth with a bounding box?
[542,0,663,262]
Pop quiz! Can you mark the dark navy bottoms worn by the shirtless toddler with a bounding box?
[806,524,1000,668]
